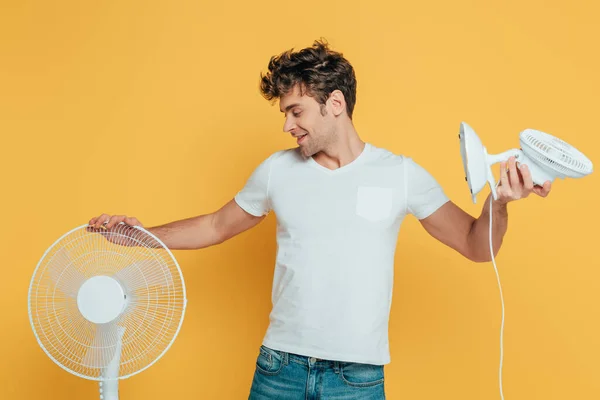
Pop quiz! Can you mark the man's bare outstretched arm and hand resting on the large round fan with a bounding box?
[89,199,265,250]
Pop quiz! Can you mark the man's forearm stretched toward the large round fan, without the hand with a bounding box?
[148,214,220,250]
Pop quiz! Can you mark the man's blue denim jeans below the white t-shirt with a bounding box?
[249,346,385,400]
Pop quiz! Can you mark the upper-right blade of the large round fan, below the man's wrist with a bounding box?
[115,259,173,293]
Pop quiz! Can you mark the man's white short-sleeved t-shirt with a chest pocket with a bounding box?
[235,143,448,365]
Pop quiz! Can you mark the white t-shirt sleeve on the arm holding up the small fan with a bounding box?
[404,157,449,219]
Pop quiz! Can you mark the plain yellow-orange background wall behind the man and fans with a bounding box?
[0,0,600,400]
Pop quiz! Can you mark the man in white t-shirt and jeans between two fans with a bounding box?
[90,41,550,400]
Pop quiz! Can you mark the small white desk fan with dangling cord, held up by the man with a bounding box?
[458,122,594,400]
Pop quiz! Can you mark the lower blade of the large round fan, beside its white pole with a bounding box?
[81,323,125,374]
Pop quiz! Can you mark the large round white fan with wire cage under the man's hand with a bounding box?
[28,224,187,400]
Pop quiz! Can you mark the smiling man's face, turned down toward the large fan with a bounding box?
[279,86,335,157]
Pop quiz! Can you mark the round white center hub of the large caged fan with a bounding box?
[77,275,126,324]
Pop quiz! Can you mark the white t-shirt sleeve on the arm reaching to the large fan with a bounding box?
[235,156,273,217]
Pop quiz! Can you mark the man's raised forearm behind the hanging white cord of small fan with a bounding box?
[469,193,508,262]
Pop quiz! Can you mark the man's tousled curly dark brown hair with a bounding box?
[260,39,356,119]
